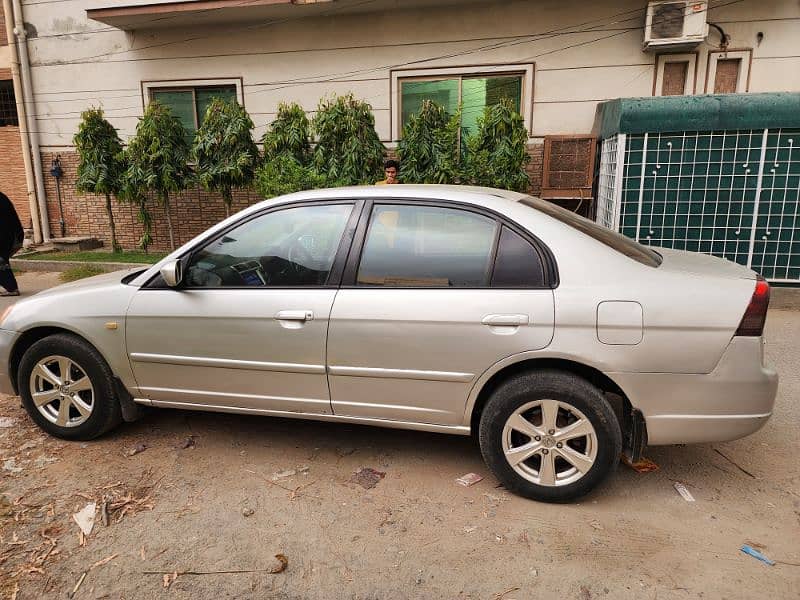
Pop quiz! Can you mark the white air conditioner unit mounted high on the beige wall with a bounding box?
[644,0,708,50]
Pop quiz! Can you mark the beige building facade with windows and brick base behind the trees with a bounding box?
[10,0,800,247]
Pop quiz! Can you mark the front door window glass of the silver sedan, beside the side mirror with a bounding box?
[185,204,353,287]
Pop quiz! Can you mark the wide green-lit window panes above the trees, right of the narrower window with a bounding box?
[400,73,525,134]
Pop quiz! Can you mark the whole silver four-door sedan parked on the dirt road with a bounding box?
[0,186,778,501]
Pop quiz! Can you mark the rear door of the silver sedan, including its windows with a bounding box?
[328,201,554,425]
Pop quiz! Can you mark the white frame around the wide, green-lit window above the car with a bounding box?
[391,63,535,142]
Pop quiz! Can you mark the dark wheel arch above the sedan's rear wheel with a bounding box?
[465,357,634,435]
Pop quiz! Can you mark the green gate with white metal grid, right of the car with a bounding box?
[597,129,800,282]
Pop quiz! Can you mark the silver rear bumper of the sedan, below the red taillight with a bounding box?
[609,337,778,446]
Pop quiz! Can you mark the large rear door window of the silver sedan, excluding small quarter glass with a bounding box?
[358,205,497,287]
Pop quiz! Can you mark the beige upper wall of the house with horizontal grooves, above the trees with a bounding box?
[17,0,800,148]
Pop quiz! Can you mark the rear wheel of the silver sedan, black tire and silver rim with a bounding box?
[478,370,622,502]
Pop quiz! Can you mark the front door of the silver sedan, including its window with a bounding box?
[126,202,357,413]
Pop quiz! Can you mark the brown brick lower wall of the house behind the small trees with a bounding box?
[40,146,544,250]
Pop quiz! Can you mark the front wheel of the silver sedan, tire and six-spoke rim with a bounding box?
[17,334,122,440]
